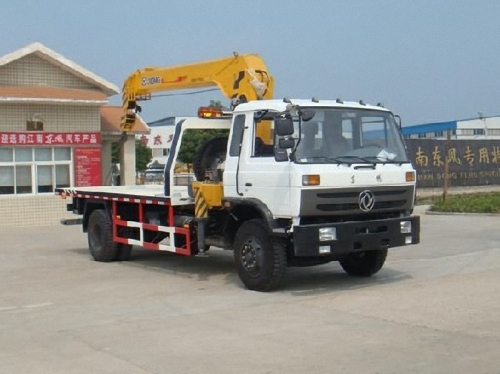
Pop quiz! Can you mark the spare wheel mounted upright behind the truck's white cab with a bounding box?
[193,137,227,181]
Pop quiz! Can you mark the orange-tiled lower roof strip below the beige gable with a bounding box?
[0,85,108,105]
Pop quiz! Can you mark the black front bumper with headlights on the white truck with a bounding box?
[293,216,420,257]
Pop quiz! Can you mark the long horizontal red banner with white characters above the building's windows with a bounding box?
[0,132,101,146]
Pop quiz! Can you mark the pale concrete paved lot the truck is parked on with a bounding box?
[0,206,500,374]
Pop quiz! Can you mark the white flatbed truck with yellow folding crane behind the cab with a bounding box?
[56,56,420,291]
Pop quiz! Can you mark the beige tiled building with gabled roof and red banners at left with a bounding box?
[0,43,148,227]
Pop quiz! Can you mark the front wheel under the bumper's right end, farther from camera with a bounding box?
[339,249,387,277]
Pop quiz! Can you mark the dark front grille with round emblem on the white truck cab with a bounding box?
[300,186,414,216]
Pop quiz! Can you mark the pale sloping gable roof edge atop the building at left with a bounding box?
[0,42,120,96]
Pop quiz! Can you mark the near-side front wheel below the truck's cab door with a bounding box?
[234,219,286,291]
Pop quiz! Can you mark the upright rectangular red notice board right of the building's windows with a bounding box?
[75,147,101,187]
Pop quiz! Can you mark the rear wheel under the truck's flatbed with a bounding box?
[88,209,118,262]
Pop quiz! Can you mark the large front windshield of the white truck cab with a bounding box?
[294,108,409,164]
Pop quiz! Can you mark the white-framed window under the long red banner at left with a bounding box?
[0,147,73,195]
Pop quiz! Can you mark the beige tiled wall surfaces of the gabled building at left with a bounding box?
[0,54,106,227]
